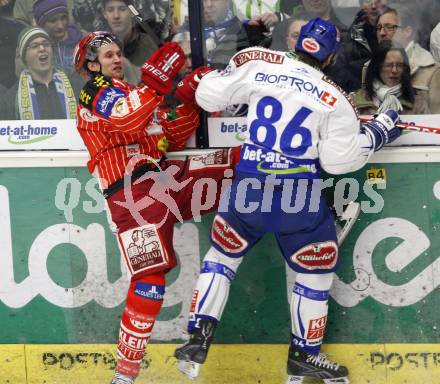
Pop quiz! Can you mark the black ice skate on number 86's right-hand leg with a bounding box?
[287,346,349,384]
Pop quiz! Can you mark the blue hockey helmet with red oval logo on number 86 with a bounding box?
[295,17,341,62]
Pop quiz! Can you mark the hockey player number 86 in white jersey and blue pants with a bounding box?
[175,18,400,384]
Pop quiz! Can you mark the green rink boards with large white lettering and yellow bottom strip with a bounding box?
[0,147,440,384]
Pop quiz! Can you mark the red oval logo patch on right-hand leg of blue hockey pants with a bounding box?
[290,241,338,271]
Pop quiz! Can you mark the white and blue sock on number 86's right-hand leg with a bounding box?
[290,273,333,355]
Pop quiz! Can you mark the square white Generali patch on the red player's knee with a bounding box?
[118,224,169,275]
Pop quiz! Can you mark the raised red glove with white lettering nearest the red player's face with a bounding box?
[141,42,185,95]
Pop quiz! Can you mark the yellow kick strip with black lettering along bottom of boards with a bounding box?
[0,344,440,384]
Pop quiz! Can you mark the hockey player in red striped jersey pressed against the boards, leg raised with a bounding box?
[74,32,238,384]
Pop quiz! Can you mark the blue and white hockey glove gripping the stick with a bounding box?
[362,109,401,151]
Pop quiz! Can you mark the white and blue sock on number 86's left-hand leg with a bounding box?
[188,247,243,333]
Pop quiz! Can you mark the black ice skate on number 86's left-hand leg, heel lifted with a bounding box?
[174,319,217,379]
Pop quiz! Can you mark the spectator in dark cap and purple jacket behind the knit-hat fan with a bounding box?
[33,0,82,73]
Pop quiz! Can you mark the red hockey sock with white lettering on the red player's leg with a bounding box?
[116,272,165,377]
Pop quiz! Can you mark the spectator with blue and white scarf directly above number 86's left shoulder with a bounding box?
[203,0,249,69]
